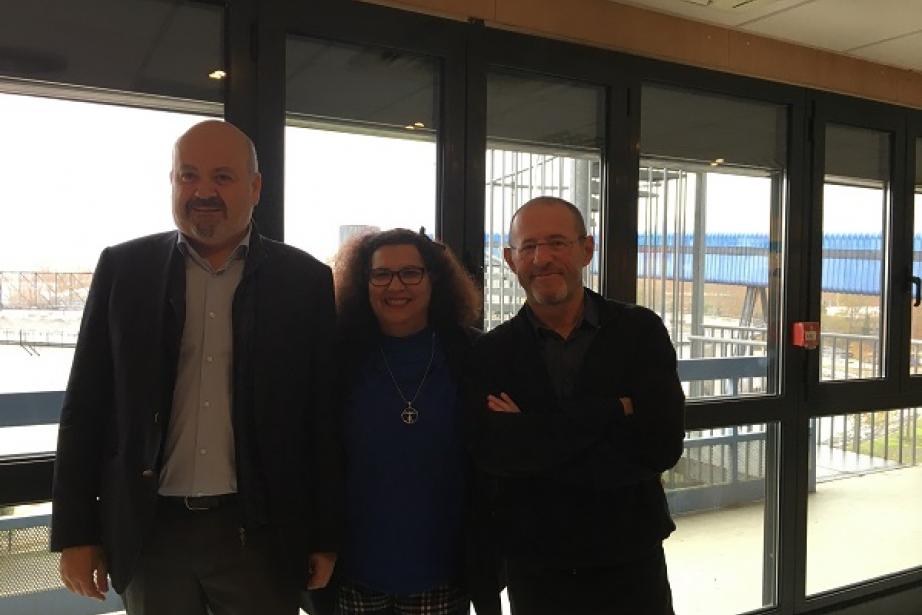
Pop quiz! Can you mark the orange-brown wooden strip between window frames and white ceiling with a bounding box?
[356,0,922,108]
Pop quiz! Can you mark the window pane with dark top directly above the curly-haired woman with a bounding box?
[285,37,439,263]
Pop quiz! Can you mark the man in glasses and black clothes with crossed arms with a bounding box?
[468,197,685,615]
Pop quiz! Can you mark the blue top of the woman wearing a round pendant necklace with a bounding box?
[337,328,466,594]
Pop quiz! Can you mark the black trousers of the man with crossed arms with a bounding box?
[507,546,675,615]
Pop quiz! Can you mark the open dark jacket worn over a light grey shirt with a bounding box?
[51,229,342,592]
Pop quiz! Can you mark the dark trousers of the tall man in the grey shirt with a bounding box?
[122,504,298,615]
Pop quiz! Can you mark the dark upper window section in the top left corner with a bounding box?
[0,0,226,102]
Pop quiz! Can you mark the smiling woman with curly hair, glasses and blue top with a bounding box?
[334,229,490,615]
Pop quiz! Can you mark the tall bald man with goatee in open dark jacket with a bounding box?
[51,120,342,615]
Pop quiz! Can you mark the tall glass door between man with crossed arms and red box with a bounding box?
[636,84,788,615]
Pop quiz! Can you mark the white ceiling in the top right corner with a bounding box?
[616,0,922,72]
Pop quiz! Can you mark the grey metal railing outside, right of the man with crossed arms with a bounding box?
[663,324,922,512]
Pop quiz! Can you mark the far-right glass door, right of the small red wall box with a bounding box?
[802,97,922,606]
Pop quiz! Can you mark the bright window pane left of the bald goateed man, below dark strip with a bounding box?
[0,93,212,456]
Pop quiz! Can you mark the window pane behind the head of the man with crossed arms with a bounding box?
[484,73,605,330]
